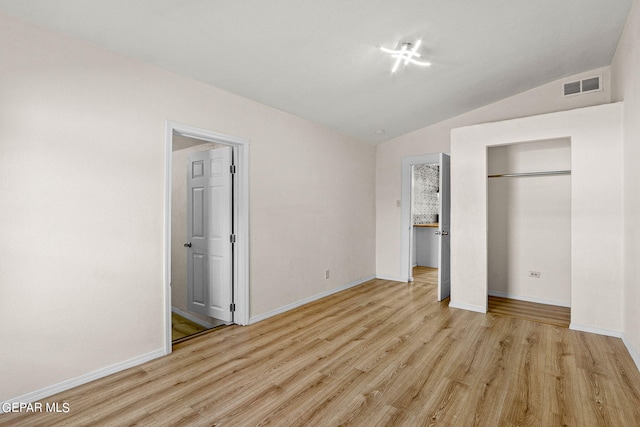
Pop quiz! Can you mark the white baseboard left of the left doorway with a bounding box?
[0,348,165,413]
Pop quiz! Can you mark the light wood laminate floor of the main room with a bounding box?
[0,272,640,427]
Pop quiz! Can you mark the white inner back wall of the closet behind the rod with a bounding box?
[487,139,572,306]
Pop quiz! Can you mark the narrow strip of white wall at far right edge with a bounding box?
[611,1,640,367]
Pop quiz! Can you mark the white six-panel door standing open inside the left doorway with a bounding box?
[185,147,233,322]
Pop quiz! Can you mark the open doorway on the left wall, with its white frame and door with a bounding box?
[164,122,249,354]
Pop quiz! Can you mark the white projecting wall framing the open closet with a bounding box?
[450,103,623,335]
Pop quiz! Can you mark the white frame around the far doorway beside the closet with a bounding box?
[400,153,440,282]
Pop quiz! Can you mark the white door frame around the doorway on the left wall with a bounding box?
[163,120,249,354]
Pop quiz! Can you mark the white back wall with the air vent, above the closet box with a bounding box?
[376,67,611,280]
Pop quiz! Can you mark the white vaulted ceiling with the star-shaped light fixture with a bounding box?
[0,0,632,143]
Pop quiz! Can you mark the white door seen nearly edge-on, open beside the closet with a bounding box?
[438,153,451,301]
